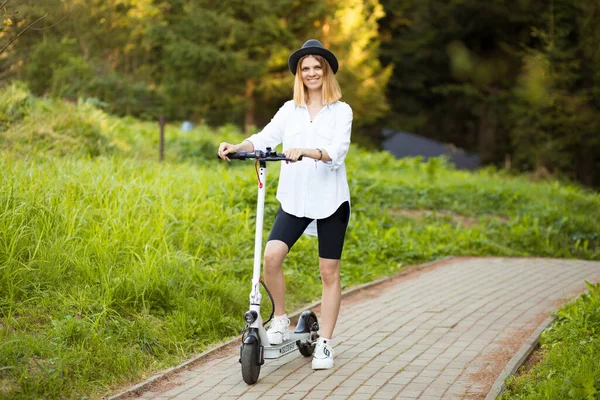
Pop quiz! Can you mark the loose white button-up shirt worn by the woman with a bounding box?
[247,100,352,223]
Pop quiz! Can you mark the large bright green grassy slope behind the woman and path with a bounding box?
[0,83,600,399]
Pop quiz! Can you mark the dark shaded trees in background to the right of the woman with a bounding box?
[380,0,600,186]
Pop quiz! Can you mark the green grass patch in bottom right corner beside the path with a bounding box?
[502,283,600,399]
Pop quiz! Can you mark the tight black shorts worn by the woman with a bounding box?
[269,201,350,260]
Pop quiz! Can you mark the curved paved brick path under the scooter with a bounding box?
[127,258,600,400]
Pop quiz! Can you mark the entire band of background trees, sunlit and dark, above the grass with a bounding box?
[0,0,600,187]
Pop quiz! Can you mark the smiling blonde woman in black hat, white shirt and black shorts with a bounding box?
[219,39,352,369]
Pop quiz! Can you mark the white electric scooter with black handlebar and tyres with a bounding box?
[218,147,319,385]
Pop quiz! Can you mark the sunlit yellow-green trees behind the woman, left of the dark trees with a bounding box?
[4,0,391,142]
